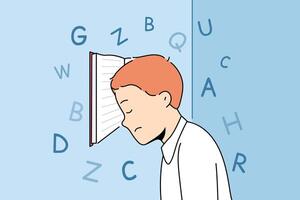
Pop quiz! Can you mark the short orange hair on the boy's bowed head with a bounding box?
[111,55,183,108]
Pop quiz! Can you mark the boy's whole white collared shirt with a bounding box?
[160,117,231,200]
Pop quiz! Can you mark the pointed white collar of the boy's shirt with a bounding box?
[161,116,186,164]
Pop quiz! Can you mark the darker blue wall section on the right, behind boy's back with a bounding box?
[193,0,300,200]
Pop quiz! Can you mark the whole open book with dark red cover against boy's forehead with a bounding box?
[89,52,132,146]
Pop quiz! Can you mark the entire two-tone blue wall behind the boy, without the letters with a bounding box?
[0,0,300,200]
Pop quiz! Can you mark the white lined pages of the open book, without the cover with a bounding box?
[93,54,130,143]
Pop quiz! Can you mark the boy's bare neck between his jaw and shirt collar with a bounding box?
[161,108,181,143]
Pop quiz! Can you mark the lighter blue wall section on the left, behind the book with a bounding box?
[0,0,191,200]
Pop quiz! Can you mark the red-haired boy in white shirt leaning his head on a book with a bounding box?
[111,55,231,200]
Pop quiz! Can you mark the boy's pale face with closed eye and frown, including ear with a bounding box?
[114,85,166,144]
